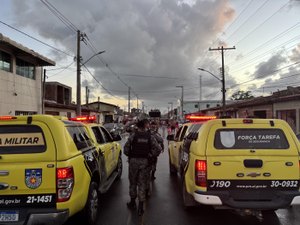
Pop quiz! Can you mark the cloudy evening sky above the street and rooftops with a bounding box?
[0,0,300,112]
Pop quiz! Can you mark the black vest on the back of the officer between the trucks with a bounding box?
[129,131,151,158]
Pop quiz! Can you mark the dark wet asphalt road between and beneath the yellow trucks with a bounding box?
[65,132,300,225]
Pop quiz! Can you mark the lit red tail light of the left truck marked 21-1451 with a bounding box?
[56,167,74,202]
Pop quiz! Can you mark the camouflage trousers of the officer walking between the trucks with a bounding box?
[128,158,150,201]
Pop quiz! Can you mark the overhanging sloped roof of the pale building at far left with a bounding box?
[0,33,55,66]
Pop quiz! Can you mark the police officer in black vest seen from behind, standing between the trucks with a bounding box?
[124,119,161,216]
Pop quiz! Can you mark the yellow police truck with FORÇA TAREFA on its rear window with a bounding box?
[182,119,300,212]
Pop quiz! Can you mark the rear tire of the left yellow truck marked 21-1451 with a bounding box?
[83,181,99,225]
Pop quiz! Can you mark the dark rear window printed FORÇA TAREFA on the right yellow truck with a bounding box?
[214,129,289,150]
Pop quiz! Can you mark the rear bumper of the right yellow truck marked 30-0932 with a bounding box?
[193,191,300,210]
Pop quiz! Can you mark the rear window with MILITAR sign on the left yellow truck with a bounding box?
[0,125,47,154]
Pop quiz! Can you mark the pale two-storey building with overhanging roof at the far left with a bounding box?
[0,33,55,115]
